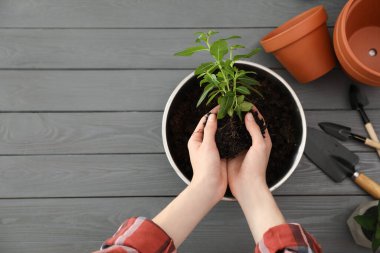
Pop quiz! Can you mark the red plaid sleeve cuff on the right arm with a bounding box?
[255,224,322,253]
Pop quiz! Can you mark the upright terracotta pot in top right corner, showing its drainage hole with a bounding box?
[334,0,380,86]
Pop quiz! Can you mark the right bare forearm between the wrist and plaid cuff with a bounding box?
[239,182,286,243]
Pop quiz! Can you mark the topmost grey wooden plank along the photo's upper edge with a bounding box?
[0,0,346,28]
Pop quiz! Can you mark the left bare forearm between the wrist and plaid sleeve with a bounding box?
[153,185,219,247]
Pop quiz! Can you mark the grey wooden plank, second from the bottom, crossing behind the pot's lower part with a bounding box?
[0,152,380,198]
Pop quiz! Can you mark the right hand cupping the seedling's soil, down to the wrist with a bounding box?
[227,108,272,202]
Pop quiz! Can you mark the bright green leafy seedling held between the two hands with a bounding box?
[175,31,262,120]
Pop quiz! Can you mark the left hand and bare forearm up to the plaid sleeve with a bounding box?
[153,107,227,247]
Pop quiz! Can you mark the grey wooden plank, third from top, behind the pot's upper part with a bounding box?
[0,69,380,112]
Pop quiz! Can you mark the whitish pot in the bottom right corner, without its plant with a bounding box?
[347,200,379,248]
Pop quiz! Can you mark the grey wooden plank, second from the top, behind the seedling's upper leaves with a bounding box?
[0,28,336,69]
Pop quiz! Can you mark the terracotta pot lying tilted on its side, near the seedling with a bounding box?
[260,5,335,83]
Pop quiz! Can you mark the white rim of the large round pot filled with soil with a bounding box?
[162,61,307,200]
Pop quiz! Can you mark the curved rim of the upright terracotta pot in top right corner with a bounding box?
[335,0,380,84]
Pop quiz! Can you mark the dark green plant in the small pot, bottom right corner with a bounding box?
[354,201,380,252]
